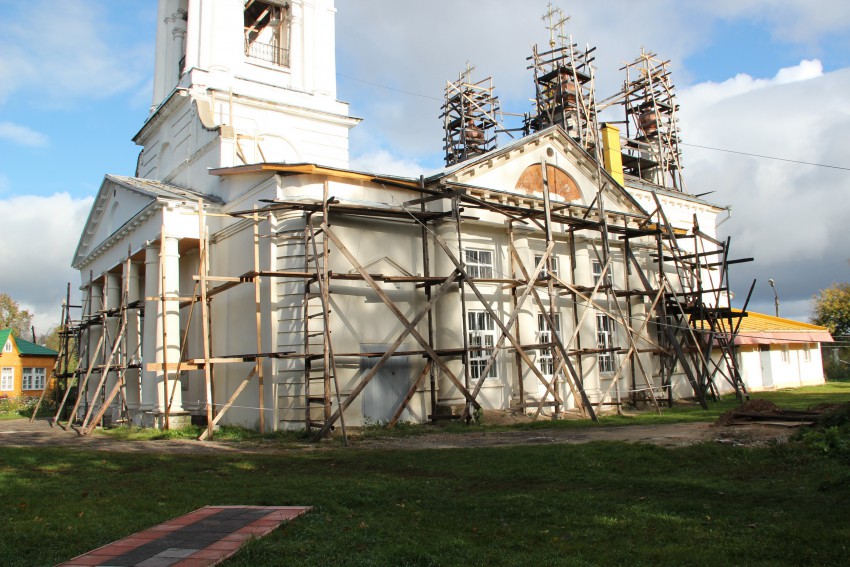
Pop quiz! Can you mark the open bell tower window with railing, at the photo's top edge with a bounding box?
[245,0,292,67]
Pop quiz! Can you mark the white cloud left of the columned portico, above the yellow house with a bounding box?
[0,193,92,333]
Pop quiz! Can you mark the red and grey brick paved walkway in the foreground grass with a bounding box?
[59,506,310,567]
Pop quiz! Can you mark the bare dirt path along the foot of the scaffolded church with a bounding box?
[0,419,793,454]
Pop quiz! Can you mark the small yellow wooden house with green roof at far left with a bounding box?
[0,329,59,398]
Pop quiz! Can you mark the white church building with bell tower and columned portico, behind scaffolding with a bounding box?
[73,0,824,431]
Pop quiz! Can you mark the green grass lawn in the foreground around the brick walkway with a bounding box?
[0,385,850,566]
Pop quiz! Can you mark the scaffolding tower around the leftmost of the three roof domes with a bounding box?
[440,64,500,166]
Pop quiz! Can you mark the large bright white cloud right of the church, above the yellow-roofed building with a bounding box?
[680,65,850,319]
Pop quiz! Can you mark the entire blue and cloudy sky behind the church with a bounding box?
[0,0,850,331]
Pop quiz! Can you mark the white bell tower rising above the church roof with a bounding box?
[134,0,358,191]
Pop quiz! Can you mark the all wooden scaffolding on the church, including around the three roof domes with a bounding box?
[46,4,752,439]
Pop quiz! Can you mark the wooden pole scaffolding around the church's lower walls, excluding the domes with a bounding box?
[51,153,746,438]
